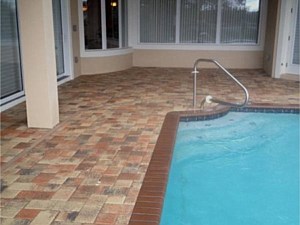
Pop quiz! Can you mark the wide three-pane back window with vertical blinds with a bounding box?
[140,0,260,44]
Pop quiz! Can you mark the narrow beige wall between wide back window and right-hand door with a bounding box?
[264,0,279,76]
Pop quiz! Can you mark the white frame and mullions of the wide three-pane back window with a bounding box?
[133,0,268,51]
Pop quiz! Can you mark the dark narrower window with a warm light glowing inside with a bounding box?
[82,0,127,50]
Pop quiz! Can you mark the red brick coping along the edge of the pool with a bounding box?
[129,104,299,225]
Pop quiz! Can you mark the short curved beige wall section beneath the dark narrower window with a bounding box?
[81,53,132,75]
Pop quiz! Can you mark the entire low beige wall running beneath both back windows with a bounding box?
[80,49,264,75]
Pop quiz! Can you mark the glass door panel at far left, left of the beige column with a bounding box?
[0,0,24,100]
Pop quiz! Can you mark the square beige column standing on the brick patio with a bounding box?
[18,0,59,128]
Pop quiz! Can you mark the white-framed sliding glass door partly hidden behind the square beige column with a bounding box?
[0,0,71,111]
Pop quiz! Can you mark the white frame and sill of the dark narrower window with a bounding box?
[77,0,133,57]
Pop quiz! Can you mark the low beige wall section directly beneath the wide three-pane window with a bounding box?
[133,49,263,69]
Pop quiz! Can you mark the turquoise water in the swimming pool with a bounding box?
[160,112,299,225]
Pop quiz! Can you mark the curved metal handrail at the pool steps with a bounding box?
[192,59,249,108]
